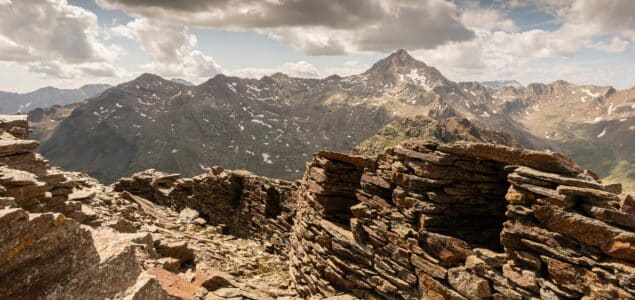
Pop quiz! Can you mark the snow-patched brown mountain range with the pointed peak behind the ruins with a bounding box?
[29,50,635,190]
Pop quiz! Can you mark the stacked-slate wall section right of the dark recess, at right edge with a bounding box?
[496,166,635,299]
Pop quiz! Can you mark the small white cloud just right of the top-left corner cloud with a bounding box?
[112,18,221,81]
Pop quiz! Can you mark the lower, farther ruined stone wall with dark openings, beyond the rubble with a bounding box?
[114,167,296,254]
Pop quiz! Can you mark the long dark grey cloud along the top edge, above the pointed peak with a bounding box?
[97,0,474,55]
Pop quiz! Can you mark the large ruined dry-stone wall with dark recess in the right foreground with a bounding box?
[290,141,635,299]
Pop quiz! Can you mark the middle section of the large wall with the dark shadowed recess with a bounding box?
[382,141,507,247]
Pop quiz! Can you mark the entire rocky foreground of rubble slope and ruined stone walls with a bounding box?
[0,118,635,299]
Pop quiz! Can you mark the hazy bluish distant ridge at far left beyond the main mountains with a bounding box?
[0,84,110,113]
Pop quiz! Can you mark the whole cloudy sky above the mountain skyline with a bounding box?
[0,0,635,92]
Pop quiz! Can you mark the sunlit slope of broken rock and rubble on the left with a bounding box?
[0,117,295,299]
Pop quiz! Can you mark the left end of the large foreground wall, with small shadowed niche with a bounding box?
[291,151,400,299]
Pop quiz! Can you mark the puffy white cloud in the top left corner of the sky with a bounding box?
[0,0,121,79]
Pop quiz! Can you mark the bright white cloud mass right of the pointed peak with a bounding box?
[413,0,635,84]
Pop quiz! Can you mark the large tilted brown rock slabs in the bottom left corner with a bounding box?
[0,208,165,299]
